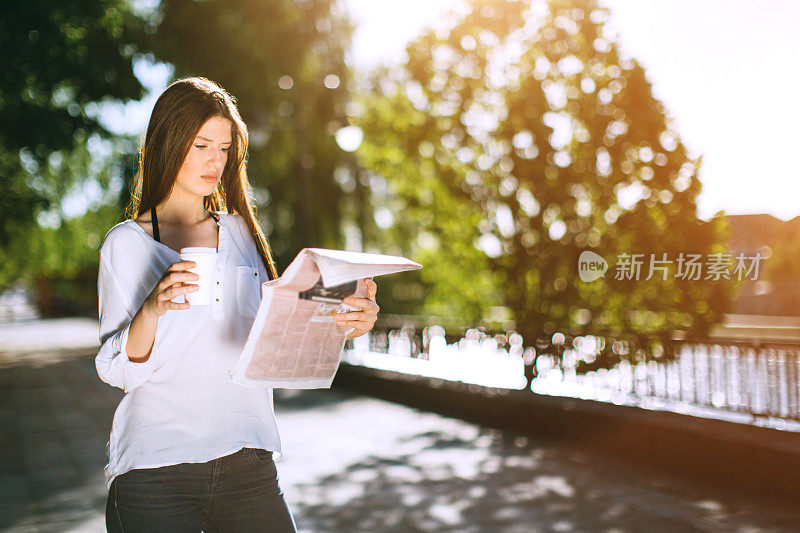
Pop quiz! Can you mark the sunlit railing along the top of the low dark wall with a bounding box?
[345,323,800,422]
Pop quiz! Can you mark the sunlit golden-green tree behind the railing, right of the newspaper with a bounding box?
[357,0,729,342]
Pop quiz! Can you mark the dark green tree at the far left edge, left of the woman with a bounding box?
[0,0,143,310]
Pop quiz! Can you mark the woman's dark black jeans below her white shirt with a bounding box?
[106,448,297,533]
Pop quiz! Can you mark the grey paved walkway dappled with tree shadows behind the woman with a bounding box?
[0,323,800,533]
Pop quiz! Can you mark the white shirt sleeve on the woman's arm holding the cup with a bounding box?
[95,232,158,392]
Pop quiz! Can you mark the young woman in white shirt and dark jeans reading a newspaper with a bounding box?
[95,78,378,532]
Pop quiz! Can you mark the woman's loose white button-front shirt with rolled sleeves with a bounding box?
[95,211,281,488]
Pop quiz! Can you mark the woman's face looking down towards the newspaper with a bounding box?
[175,117,231,196]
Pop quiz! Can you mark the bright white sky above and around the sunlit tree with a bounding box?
[345,0,800,220]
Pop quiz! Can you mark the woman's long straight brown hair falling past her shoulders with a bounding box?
[125,77,278,279]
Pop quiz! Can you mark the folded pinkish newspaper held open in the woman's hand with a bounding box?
[228,248,422,389]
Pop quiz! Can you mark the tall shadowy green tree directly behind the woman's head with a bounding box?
[137,0,352,270]
